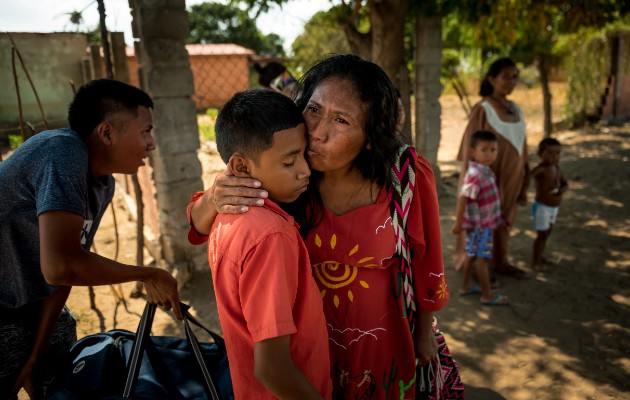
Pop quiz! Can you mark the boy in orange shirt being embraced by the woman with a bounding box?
[188,89,332,400]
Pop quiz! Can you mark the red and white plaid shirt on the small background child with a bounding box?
[460,160,501,229]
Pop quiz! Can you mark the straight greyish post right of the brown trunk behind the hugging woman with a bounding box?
[414,13,442,182]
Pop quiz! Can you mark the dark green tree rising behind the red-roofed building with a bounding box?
[188,2,284,56]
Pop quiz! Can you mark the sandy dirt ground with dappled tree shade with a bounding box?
[60,85,630,400]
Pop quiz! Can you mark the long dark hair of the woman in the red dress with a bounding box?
[291,54,402,234]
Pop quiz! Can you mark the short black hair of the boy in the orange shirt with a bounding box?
[214,89,304,164]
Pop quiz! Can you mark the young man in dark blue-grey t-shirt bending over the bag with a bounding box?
[0,79,182,399]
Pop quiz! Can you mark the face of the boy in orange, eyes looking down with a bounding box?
[250,124,311,203]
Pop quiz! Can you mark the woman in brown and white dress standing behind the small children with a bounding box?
[454,57,529,279]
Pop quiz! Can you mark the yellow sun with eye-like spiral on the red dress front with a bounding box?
[313,234,378,308]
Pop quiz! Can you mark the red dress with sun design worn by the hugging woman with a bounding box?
[305,157,449,399]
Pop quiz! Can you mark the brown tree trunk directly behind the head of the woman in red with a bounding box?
[370,0,412,143]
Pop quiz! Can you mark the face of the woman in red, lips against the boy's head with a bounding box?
[303,77,369,172]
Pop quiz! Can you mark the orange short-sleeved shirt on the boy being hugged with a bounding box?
[195,197,332,399]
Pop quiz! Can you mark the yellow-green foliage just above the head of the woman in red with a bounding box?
[288,10,350,76]
